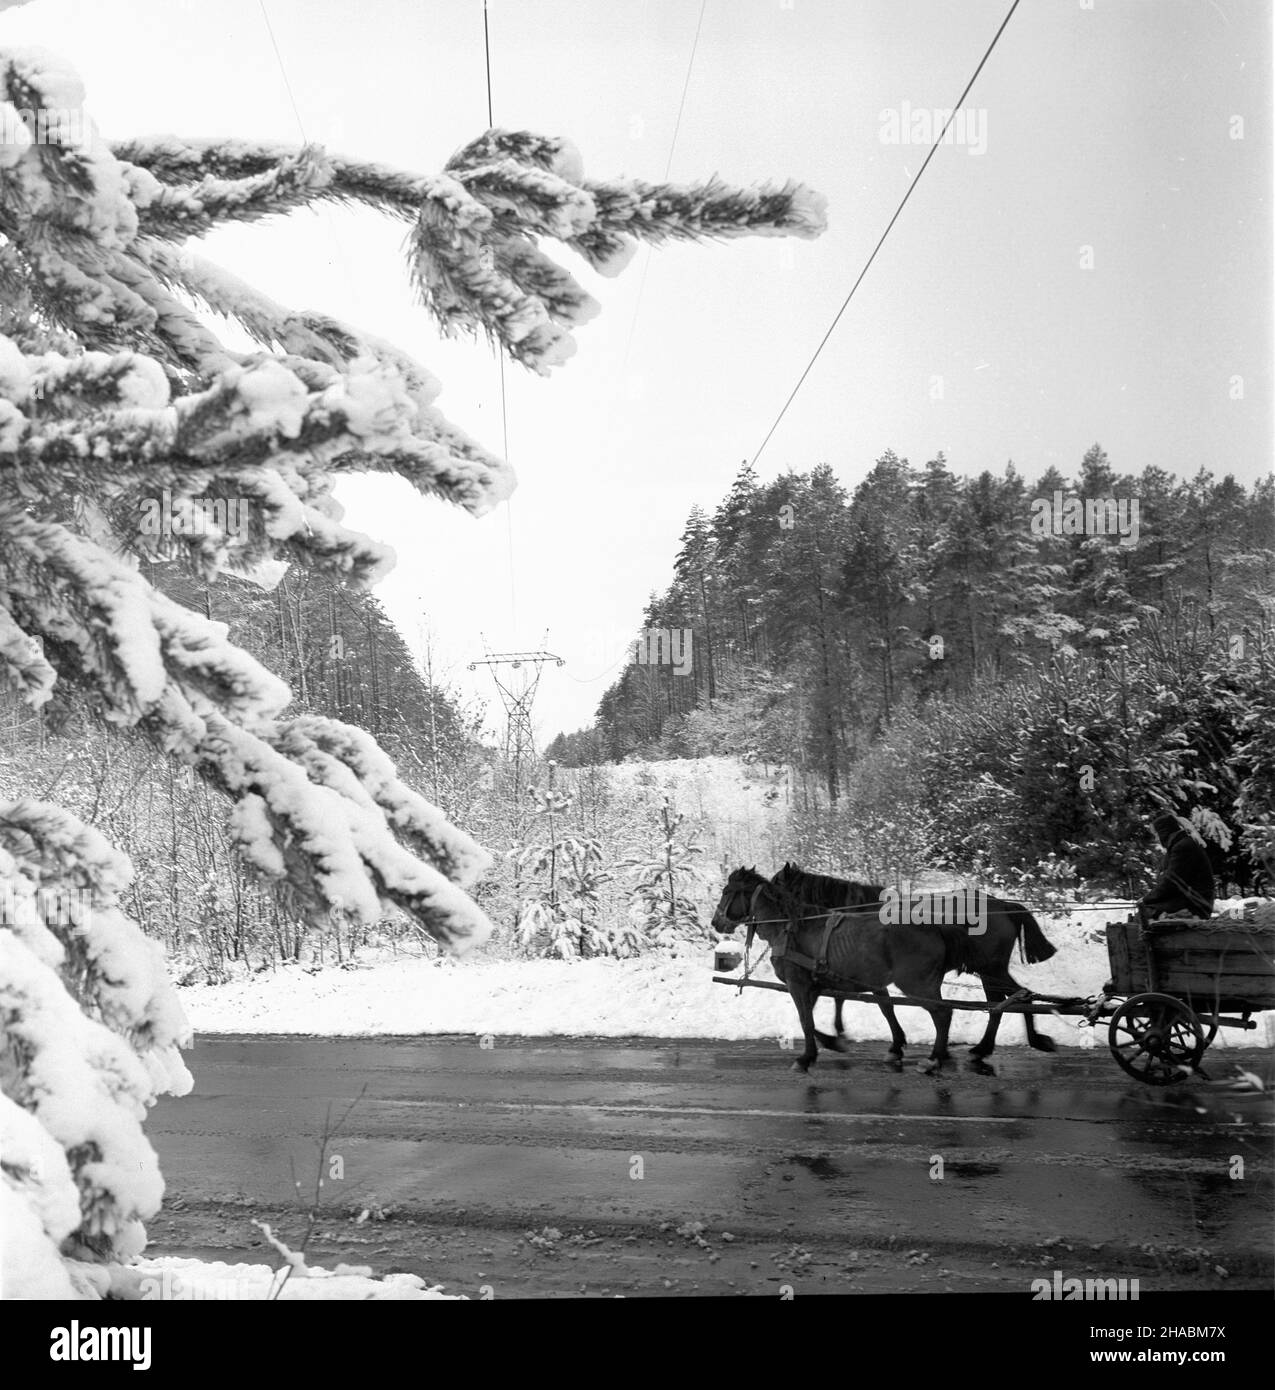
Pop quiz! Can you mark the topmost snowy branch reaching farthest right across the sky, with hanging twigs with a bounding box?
[114,129,825,374]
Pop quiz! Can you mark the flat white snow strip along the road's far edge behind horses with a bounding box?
[181,908,1269,1047]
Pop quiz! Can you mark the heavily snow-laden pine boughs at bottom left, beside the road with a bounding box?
[0,801,192,1298]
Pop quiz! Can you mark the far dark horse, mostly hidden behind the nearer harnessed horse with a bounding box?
[773,863,1055,1072]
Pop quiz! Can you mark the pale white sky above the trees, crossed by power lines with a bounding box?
[0,0,1272,738]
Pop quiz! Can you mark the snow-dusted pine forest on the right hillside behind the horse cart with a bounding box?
[548,445,1275,891]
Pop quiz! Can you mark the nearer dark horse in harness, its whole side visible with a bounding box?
[713,869,965,1072]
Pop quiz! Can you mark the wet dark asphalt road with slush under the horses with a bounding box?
[147,1036,1275,1297]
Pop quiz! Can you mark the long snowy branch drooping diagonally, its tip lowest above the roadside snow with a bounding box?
[0,520,491,949]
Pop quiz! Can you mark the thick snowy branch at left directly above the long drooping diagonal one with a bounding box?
[0,321,513,528]
